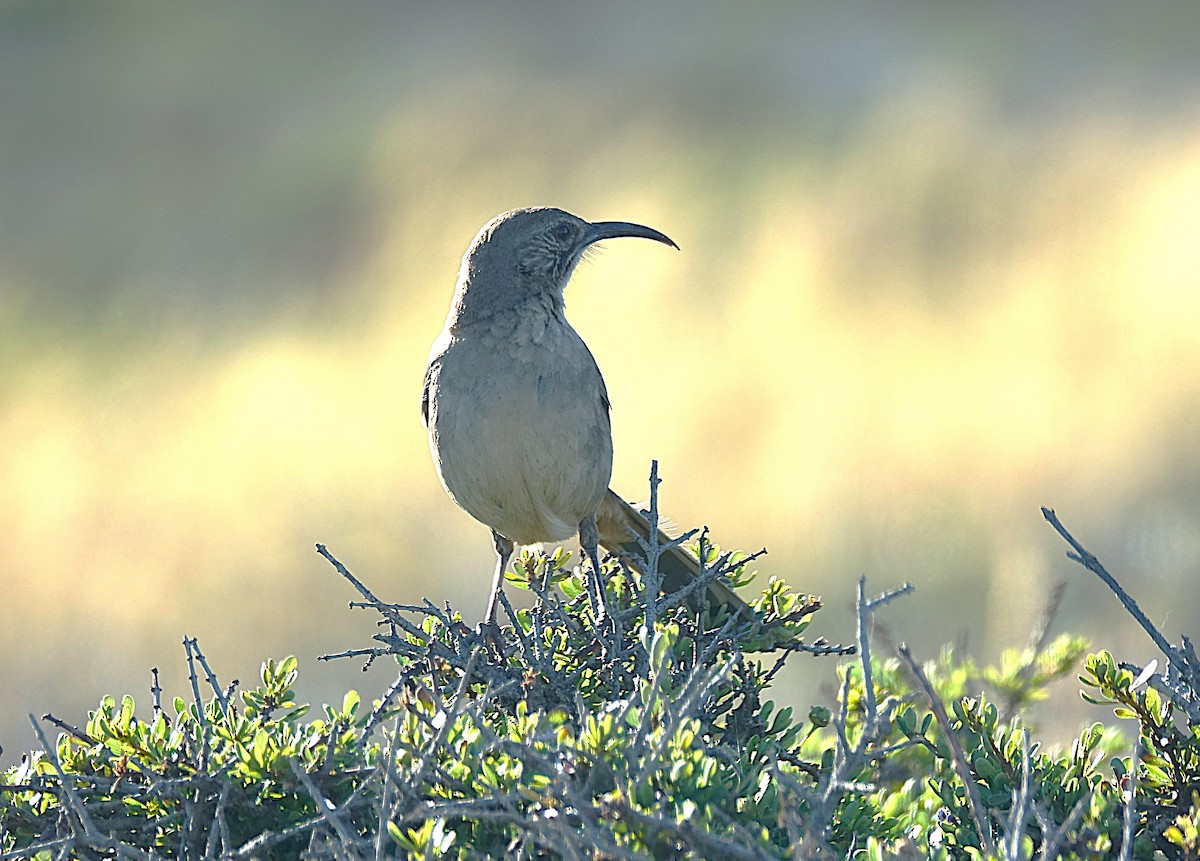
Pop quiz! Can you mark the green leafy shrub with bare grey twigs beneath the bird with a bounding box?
[0,520,1200,860]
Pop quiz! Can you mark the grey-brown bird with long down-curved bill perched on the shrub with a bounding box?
[421,206,745,627]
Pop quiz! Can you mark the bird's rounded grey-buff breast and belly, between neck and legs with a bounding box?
[430,318,612,543]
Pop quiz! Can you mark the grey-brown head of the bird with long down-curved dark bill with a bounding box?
[455,206,679,319]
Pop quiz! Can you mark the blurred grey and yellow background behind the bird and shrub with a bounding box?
[0,0,1200,764]
